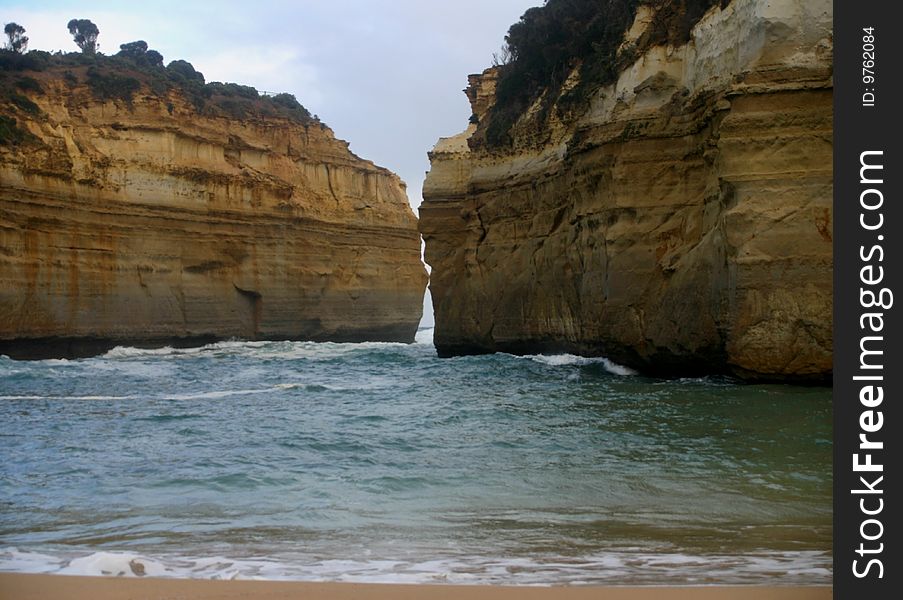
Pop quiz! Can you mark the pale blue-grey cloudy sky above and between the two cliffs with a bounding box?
[0,0,542,216]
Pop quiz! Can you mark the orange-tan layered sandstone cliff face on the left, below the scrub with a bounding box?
[0,73,426,356]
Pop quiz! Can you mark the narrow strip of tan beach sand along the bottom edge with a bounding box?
[0,573,833,600]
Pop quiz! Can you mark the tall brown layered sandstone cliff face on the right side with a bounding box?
[420,0,833,381]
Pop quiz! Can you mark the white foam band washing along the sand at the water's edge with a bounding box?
[0,548,832,585]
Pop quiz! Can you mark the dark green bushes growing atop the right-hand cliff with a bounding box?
[473,0,730,147]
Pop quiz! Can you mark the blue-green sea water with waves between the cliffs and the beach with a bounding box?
[0,330,832,585]
